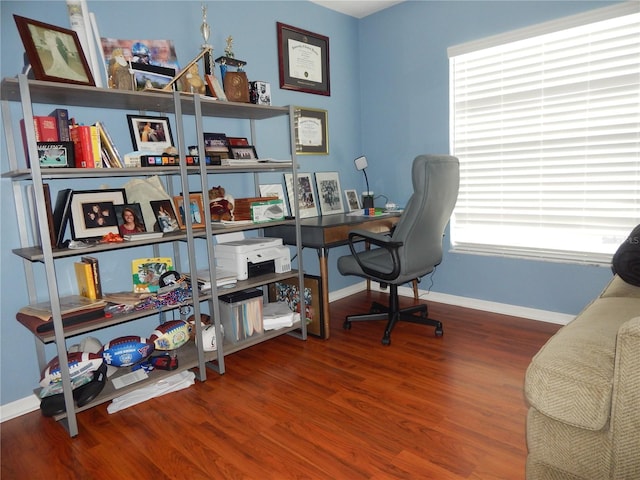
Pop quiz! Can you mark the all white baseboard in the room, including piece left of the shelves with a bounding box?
[0,281,574,422]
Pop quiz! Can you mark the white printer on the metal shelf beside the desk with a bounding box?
[215,237,291,280]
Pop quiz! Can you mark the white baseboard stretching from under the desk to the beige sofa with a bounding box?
[329,281,575,325]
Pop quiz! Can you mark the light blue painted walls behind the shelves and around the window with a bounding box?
[0,0,610,405]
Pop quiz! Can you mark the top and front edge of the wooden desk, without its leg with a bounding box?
[265,213,400,249]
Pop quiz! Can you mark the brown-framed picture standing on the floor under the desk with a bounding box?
[269,275,325,338]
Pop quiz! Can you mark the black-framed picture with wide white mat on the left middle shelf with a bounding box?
[70,188,127,240]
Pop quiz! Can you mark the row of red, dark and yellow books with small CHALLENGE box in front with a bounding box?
[20,108,125,168]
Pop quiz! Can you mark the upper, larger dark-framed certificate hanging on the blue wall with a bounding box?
[277,22,331,96]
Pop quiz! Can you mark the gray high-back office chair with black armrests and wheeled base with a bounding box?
[338,155,460,345]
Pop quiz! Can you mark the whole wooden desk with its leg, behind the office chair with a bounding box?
[265,213,400,338]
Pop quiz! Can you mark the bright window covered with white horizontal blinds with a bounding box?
[449,2,640,263]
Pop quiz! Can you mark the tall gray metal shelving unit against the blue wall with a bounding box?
[0,75,306,436]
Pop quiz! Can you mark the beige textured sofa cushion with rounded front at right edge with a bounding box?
[525,297,640,430]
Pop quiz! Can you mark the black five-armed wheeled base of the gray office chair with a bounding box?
[342,285,444,345]
